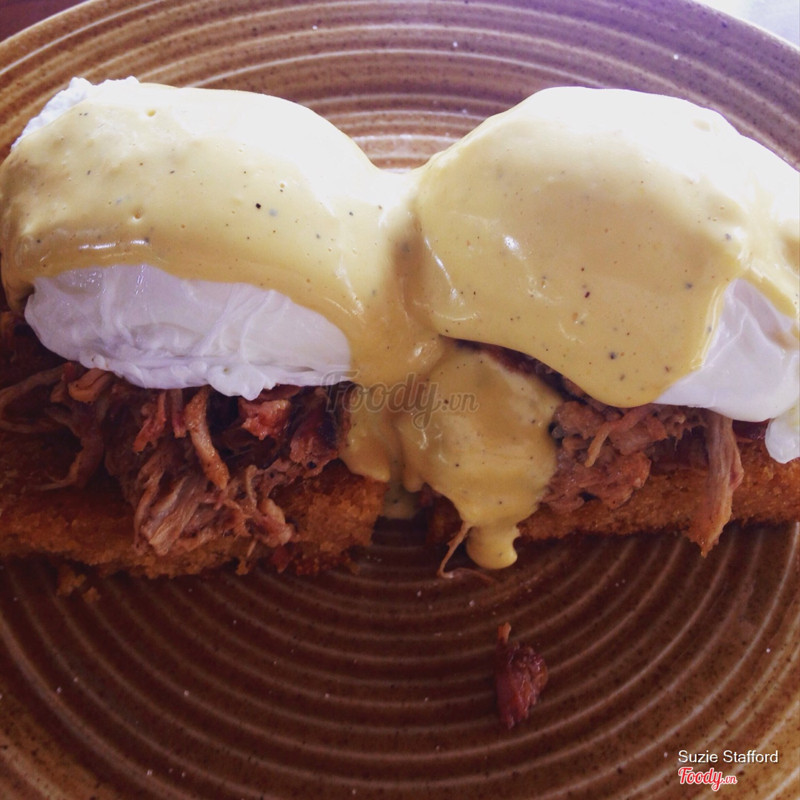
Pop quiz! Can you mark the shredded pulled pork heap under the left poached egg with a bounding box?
[0,354,343,555]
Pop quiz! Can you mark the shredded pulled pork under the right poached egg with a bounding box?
[490,347,752,554]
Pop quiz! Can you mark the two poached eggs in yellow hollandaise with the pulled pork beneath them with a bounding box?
[0,79,800,568]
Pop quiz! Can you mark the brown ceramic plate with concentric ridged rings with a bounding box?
[0,0,800,800]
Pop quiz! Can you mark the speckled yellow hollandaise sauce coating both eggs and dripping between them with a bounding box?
[0,80,800,567]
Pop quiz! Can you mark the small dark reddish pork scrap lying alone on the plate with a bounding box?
[494,622,547,730]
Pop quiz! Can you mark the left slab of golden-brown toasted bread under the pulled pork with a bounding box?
[0,433,384,577]
